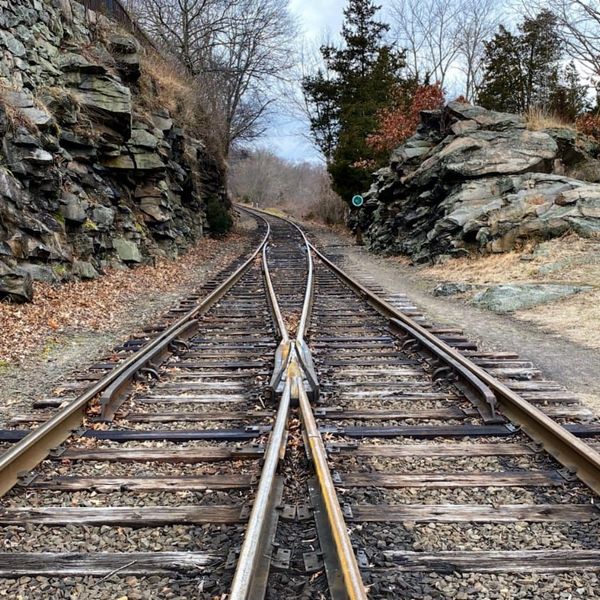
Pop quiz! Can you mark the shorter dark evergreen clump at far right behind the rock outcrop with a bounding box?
[478,11,585,119]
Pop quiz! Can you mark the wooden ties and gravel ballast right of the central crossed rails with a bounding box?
[309,258,600,598]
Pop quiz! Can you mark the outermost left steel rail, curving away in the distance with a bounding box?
[0,215,270,496]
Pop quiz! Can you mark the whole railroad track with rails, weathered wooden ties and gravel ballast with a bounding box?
[0,211,600,600]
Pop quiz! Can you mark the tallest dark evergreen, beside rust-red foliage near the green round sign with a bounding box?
[303,0,404,201]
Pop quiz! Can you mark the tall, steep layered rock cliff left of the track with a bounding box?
[0,0,228,300]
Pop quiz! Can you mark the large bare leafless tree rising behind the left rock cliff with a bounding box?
[132,0,296,156]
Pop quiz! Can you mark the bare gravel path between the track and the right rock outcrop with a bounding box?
[309,226,600,415]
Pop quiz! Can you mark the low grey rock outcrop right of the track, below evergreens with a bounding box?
[350,102,600,262]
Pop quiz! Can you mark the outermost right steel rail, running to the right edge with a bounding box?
[309,242,600,494]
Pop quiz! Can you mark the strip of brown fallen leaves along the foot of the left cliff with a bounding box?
[0,234,241,364]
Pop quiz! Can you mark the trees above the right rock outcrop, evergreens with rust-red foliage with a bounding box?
[303,0,600,201]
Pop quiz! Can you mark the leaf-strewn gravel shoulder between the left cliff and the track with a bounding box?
[0,217,256,415]
